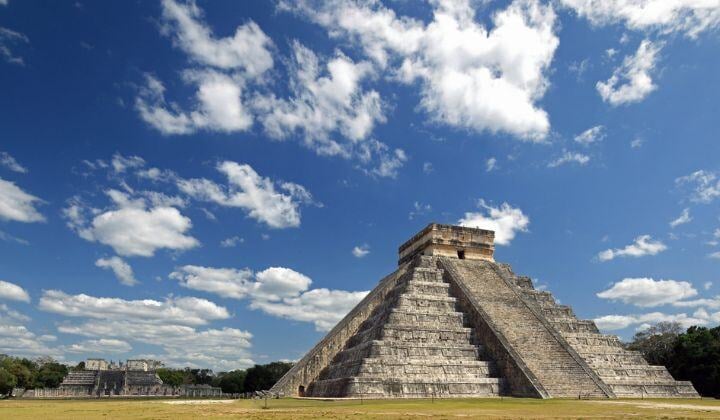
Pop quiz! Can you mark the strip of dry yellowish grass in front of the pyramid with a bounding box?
[0,398,720,420]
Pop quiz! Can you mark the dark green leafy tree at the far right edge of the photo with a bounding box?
[667,327,720,397]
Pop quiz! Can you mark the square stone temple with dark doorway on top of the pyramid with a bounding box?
[398,223,495,265]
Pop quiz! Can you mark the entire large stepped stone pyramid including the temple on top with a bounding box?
[271,223,698,398]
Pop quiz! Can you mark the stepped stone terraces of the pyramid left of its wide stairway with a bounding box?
[305,257,504,398]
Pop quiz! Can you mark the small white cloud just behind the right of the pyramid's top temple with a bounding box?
[458,200,530,245]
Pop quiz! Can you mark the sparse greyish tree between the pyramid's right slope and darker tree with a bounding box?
[627,322,682,366]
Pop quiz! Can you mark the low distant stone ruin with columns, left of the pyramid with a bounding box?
[23,359,222,398]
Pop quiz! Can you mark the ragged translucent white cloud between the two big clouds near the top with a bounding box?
[253,42,406,172]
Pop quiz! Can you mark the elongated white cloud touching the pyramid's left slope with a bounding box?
[170,265,368,331]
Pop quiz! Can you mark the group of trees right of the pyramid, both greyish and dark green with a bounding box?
[626,322,720,398]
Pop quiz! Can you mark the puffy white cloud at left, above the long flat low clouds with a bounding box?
[63,190,199,257]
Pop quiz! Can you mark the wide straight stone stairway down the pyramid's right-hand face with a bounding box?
[438,257,614,398]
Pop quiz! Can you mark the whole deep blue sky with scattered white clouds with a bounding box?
[0,0,720,370]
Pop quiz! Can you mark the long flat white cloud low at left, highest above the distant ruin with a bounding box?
[38,290,230,326]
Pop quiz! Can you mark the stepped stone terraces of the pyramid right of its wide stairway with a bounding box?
[510,272,698,398]
